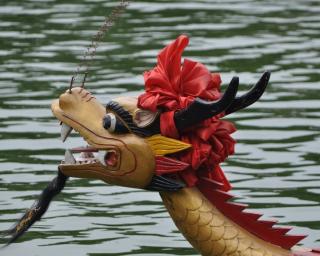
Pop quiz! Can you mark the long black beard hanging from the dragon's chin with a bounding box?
[2,170,68,245]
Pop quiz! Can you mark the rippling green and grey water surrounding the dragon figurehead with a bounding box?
[0,0,320,256]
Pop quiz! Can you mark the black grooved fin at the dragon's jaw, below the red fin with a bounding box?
[145,175,185,192]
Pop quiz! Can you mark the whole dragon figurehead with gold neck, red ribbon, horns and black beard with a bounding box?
[7,35,320,256]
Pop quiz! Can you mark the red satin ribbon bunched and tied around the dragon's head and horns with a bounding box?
[138,35,236,191]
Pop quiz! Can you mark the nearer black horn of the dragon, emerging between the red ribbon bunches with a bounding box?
[174,77,239,131]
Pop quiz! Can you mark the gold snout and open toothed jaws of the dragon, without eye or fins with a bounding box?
[51,87,155,188]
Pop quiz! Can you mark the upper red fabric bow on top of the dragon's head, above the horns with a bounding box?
[138,35,221,111]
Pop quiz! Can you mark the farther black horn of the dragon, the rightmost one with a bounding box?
[225,72,271,115]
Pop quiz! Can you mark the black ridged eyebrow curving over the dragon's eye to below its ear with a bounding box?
[106,101,160,137]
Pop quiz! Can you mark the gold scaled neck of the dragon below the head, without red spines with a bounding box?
[160,188,290,256]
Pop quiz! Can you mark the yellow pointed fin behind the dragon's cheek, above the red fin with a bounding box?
[146,134,191,156]
